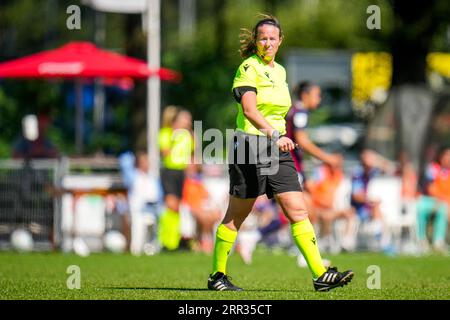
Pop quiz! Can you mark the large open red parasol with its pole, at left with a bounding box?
[0,42,181,152]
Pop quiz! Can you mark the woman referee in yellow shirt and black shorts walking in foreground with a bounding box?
[208,16,353,291]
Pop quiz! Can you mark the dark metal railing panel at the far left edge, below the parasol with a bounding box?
[0,160,61,250]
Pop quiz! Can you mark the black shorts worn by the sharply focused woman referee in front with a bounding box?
[228,131,302,199]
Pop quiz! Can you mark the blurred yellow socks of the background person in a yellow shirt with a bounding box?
[158,208,181,250]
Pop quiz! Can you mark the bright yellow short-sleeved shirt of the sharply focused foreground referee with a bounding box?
[233,54,291,135]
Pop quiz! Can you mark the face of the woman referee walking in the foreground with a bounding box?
[256,24,282,62]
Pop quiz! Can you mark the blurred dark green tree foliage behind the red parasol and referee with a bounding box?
[0,0,446,156]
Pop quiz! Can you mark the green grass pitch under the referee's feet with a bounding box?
[0,250,450,300]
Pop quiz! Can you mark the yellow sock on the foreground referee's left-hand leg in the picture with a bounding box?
[212,224,237,274]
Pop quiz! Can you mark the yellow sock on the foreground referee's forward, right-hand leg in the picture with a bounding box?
[291,219,326,279]
